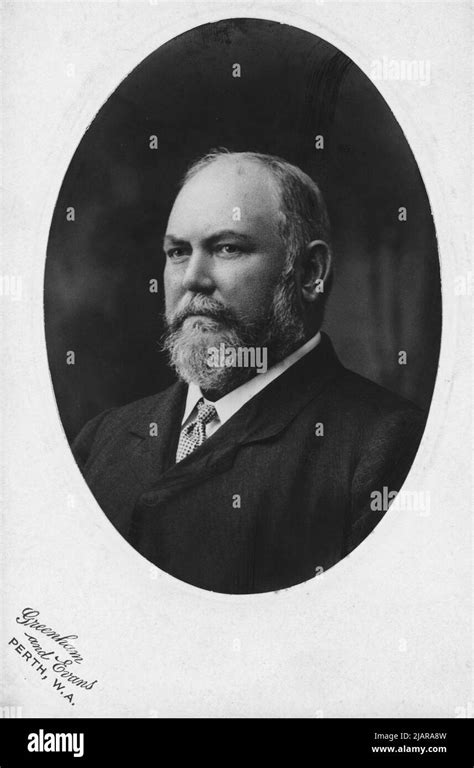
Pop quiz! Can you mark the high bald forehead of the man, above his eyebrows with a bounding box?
[167,158,281,237]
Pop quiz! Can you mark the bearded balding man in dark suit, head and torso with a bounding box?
[73,151,424,593]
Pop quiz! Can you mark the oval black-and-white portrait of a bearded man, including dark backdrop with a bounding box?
[45,19,441,594]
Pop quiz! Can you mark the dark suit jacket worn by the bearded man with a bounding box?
[73,334,424,593]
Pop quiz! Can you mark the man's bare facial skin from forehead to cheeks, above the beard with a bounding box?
[164,158,286,327]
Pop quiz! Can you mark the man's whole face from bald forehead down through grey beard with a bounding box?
[164,158,304,398]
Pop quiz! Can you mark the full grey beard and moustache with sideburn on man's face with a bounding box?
[163,270,305,399]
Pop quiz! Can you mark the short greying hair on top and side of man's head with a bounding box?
[179,147,332,311]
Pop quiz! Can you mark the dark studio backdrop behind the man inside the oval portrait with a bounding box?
[45,19,441,439]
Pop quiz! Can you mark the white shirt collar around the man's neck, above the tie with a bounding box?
[181,331,321,425]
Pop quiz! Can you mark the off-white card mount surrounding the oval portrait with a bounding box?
[4,2,472,717]
